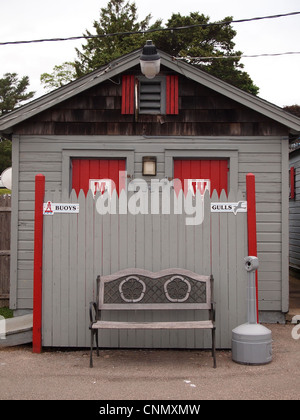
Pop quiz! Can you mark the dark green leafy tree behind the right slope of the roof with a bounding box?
[152,12,259,95]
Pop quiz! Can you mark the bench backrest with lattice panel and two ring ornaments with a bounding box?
[97,268,213,310]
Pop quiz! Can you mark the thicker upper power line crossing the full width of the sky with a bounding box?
[0,12,300,46]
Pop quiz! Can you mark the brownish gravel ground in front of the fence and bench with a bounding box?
[0,323,300,402]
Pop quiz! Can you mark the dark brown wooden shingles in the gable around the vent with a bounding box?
[15,76,288,136]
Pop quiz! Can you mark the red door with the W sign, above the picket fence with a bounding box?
[174,159,228,195]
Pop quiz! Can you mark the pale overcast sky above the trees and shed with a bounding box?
[0,0,300,106]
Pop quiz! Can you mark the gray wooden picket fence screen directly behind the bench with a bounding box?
[42,191,247,348]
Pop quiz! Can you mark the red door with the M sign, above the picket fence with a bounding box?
[72,159,126,195]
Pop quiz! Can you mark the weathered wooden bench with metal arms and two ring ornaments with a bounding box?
[89,268,216,368]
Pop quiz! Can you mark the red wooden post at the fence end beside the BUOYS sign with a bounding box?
[32,174,45,353]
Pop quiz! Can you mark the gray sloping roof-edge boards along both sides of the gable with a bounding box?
[0,49,300,134]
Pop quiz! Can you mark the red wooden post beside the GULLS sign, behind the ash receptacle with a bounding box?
[246,173,259,322]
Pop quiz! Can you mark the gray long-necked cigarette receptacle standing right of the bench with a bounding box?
[232,257,272,365]
